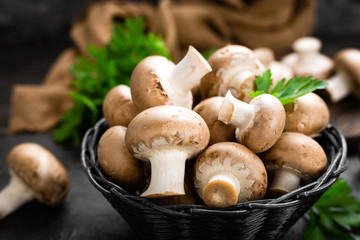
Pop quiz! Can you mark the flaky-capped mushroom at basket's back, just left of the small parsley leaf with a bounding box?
[200,45,265,102]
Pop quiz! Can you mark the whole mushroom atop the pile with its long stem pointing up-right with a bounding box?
[130,46,211,112]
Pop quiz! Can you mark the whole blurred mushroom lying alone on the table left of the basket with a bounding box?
[0,143,69,219]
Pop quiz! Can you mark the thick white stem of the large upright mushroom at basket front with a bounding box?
[141,148,188,197]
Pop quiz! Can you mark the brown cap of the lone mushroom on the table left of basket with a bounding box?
[7,143,69,206]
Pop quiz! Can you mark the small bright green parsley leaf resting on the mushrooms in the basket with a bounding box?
[249,69,327,105]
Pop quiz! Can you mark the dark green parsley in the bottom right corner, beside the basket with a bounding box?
[303,179,360,240]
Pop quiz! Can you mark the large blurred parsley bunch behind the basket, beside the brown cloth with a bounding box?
[53,18,169,145]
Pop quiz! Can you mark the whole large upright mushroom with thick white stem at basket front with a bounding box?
[125,105,210,197]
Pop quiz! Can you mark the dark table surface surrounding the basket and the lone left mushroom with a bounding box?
[0,36,360,240]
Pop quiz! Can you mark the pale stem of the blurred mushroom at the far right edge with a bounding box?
[326,70,352,102]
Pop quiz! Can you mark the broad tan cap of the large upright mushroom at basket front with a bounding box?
[125,105,210,160]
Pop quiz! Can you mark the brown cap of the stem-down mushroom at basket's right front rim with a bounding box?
[261,132,327,181]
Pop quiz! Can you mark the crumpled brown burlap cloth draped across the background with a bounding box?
[9,0,316,133]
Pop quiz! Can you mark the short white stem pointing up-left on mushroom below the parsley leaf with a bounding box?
[218,91,254,129]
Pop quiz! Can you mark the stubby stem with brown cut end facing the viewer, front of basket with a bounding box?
[203,173,240,207]
